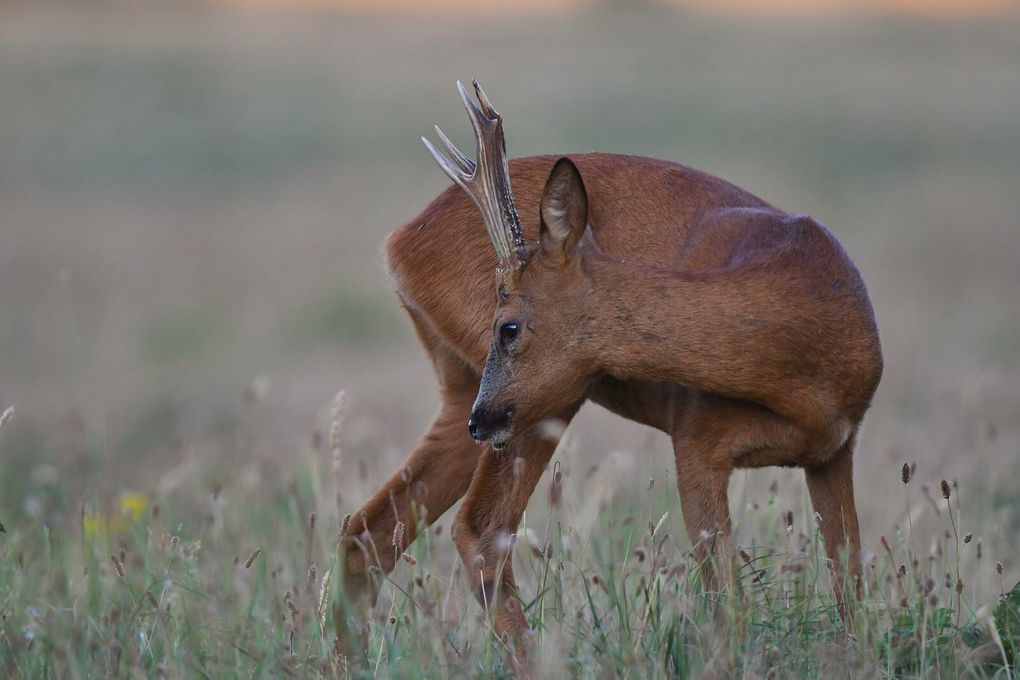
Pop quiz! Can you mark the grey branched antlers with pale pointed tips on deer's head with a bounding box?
[421,81,527,269]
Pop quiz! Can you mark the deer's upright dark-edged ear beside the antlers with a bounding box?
[539,158,588,256]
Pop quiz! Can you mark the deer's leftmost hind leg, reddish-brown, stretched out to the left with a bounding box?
[340,317,481,651]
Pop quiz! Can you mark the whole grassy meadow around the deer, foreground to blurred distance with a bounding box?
[0,4,1020,678]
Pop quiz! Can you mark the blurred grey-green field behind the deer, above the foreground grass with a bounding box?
[0,0,1020,576]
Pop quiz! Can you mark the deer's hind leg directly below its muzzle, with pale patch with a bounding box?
[454,405,579,664]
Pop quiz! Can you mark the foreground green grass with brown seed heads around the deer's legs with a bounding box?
[0,391,1020,678]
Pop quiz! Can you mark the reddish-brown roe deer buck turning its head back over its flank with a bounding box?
[345,83,882,652]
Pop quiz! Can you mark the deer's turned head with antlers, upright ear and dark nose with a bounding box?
[422,82,600,450]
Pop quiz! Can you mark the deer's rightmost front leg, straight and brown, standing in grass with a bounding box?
[804,435,861,623]
